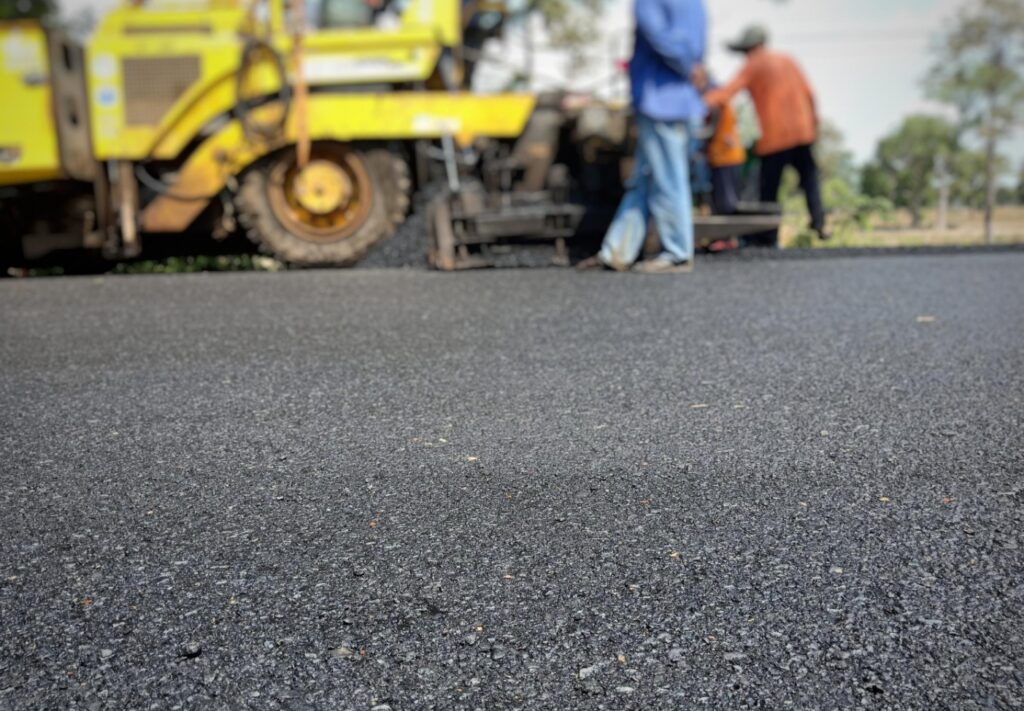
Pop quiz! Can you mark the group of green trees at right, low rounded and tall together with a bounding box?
[859,0,1024,242]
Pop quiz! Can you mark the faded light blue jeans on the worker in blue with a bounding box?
[599,116,693,269]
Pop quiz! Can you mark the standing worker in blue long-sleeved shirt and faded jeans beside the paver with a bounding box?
[581,0,708,274]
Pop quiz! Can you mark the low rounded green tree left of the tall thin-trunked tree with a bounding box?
[861,115,957,226]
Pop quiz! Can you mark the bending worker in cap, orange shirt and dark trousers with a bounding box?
[705,27,828,247]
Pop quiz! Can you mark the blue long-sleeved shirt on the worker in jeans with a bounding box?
[630,0,708,121]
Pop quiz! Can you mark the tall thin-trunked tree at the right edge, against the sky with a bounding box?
[926,0,1024,242]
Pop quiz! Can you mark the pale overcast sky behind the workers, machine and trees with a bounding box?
[61,0,1024,166]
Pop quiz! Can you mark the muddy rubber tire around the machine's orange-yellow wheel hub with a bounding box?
[234,144,394,266]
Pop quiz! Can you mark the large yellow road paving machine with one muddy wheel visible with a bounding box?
[0,0,778,269]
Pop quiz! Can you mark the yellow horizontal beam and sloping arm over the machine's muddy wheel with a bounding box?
[142,92,536,232]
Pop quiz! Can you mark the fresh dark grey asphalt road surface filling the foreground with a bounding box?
[0,253,1024,709]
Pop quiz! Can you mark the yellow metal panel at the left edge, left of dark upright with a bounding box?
[0,22,60,185]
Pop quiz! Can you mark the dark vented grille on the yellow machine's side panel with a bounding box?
[122,56,200,126]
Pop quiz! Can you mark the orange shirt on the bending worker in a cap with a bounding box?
[705,47,818,156]
